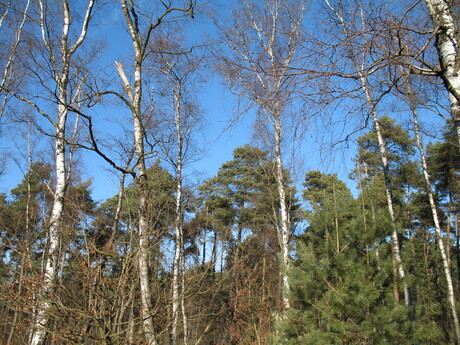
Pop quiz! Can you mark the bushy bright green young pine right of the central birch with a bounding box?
[282,171,418,344]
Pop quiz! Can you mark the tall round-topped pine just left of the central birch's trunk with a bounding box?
[196,145,298,344]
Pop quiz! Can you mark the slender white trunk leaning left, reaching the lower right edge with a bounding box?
[411,102,460,344]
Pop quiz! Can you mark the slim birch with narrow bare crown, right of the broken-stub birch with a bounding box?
[152,34,203,345]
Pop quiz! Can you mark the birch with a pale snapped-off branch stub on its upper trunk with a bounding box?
[115,0,194,345]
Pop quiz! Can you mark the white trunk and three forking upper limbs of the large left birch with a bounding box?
[30,0,94,345]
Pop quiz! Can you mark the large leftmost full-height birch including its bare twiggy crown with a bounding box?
[2,0,98,345]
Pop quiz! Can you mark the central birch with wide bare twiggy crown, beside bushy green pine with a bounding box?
[217,0,306,310]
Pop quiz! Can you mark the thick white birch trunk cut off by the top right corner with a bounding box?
[425,0,460,146]
